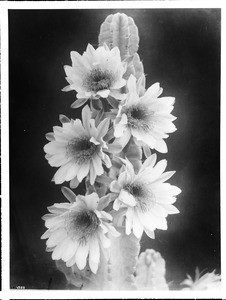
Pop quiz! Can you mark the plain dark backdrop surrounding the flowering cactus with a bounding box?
[9,9,220,289]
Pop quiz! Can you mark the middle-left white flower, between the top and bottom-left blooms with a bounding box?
[44,105,111,184]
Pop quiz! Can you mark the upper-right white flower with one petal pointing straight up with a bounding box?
[114,75,176,153]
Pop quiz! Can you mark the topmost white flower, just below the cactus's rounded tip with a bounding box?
[63,44,126,104]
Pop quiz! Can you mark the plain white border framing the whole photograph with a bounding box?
[0,1,226,300]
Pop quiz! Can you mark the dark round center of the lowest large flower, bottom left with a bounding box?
[66,210,100,244]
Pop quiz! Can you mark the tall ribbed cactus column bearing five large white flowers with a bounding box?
[42,13,221,290]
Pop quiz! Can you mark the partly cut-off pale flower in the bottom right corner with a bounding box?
[181,268,221,291]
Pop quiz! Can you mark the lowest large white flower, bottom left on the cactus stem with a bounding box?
[41,193,120,273]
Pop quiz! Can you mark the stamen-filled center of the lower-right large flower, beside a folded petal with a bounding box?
[123,183,155,213]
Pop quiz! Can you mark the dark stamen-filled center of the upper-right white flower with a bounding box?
[125,105,154,131]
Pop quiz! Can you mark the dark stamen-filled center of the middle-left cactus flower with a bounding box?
[67,137,99,164]
